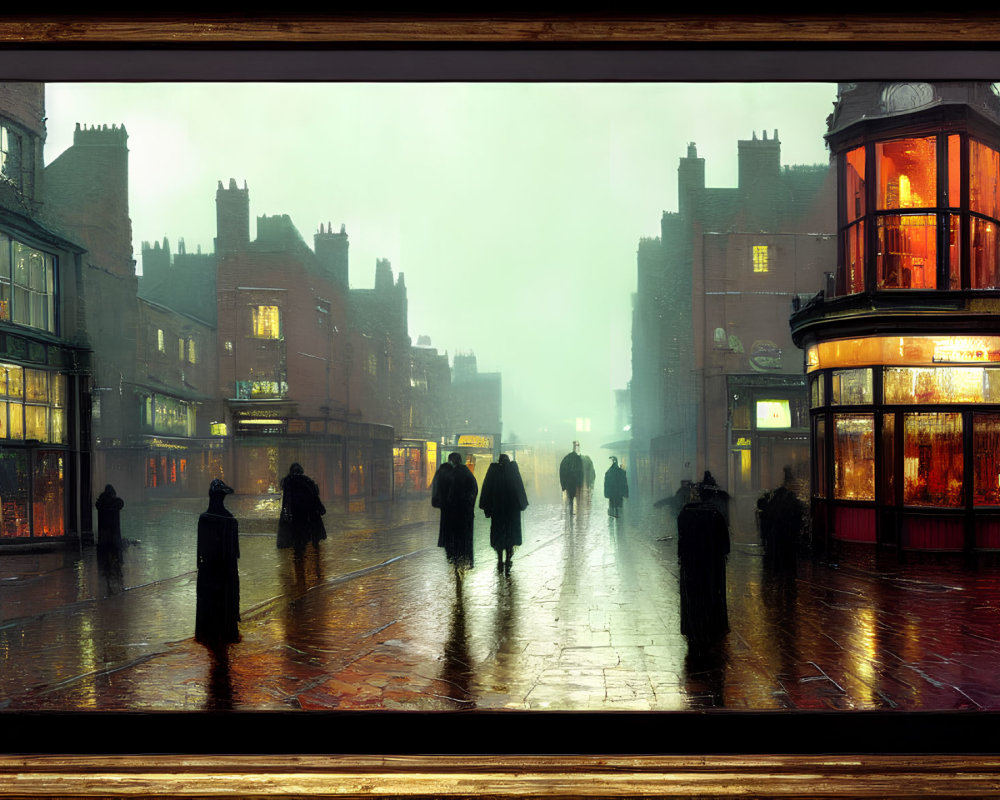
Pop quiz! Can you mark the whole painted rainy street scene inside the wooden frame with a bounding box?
[0,76,1000,712]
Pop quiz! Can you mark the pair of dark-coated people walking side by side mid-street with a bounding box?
[431,453,528,582]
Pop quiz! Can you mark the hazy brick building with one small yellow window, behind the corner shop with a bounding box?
[630,131,836,524]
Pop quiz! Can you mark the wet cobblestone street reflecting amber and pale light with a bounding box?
[0,498,1000,711]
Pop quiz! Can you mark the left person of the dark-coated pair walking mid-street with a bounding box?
[431,453,479,585]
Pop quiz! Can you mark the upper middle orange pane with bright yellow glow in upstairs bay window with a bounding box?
[875,136,937,209]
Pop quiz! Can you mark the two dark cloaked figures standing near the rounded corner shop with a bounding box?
[675,467,806,652]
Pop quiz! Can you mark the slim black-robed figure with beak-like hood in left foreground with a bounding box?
[194,478,240,648]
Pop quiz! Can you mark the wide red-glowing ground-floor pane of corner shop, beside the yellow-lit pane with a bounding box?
[903,412,963,508]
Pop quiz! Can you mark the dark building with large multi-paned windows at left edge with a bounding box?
[0,89,97,547]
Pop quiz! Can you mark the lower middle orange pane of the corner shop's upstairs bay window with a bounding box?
[877,214,937,289]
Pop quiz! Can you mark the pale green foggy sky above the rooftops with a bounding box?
[46,83,836,452]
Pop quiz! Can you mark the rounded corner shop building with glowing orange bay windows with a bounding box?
[791,82,1000,556]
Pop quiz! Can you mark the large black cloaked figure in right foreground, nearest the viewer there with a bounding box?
[677,478,729,651]
